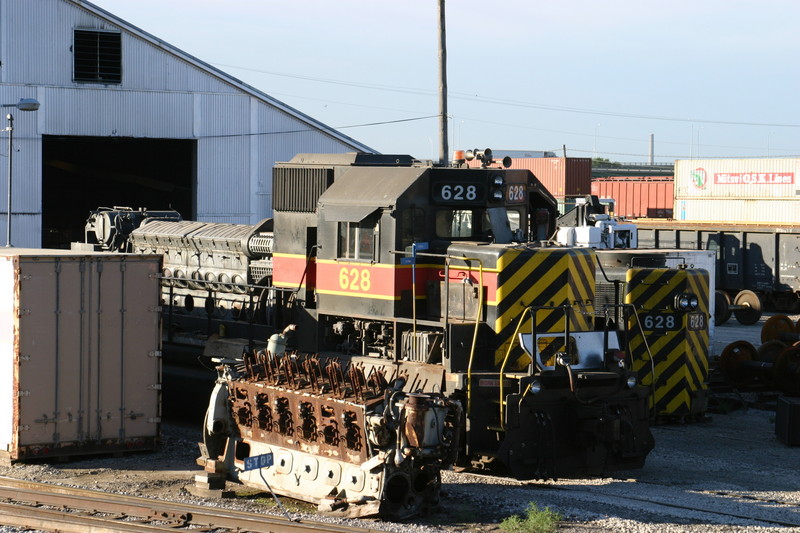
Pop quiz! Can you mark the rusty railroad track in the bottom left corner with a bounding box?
[0,477,382,533]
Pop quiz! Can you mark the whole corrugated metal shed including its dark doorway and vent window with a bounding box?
[0,0,373,247]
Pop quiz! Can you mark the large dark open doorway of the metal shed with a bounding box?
[42,135,197,248]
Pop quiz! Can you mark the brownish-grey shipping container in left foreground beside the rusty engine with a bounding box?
[0,248,161,464]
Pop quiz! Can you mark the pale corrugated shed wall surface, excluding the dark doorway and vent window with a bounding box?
[0,0,372,247]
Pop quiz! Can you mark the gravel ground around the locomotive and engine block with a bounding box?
[0,317,800,533]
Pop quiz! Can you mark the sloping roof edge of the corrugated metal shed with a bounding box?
[70,0,378,153]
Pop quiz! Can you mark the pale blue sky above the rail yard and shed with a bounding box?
[92,0,800,163]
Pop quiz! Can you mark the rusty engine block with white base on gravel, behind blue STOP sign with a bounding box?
[201,351,461,518]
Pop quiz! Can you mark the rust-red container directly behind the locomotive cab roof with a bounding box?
[469,157,592,199]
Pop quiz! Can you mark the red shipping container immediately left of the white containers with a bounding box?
[592,176,675,218]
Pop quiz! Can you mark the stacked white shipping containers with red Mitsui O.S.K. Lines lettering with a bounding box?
[674,158,800,224]
